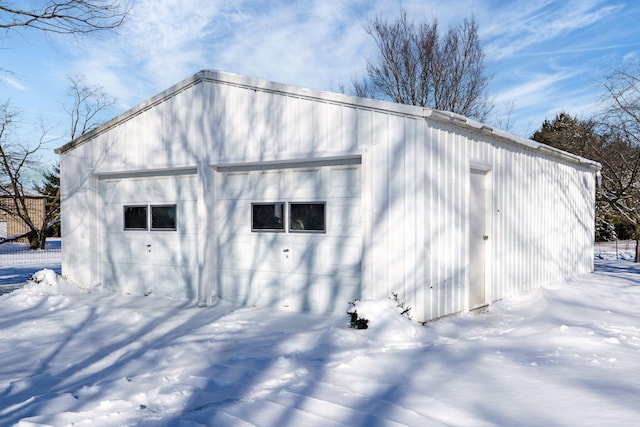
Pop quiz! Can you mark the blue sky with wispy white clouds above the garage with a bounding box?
[0,0,640,160]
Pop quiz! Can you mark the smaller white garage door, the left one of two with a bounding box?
[99,175,197,299]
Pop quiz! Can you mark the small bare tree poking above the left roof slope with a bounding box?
[64,74,116,140]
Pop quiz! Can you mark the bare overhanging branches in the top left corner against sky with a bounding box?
[0,0,130,34]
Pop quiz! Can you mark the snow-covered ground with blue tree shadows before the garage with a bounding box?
[0,246,640,427]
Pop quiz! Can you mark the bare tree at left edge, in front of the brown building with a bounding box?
[0,102,52,249]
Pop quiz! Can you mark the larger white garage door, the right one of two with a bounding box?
[216,160,362,312]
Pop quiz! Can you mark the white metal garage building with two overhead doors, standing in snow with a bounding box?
[58,71,599,321]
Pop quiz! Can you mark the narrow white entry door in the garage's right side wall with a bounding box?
[468,169,489,310]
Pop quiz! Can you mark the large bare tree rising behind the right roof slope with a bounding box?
[353,10,493,121]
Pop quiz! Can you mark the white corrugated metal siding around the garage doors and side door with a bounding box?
[61,72,595,320]
